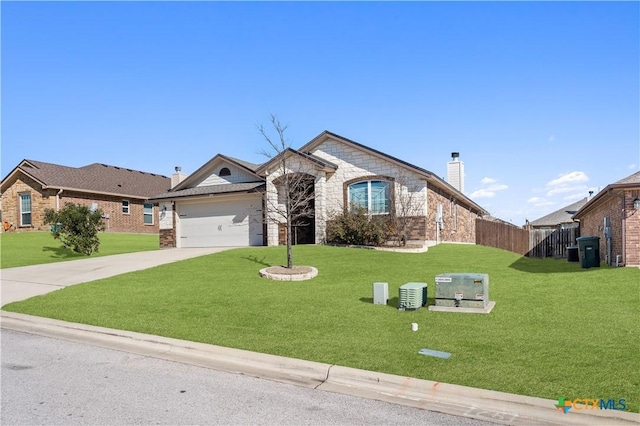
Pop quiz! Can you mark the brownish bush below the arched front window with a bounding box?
[327,206,390,246]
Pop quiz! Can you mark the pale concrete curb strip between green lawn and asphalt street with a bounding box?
[0,311,640,425]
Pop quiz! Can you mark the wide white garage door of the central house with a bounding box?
[176,197,263,247]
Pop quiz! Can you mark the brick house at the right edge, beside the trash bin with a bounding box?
[573,172,640,266]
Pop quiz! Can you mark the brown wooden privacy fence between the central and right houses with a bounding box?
[476,219,580,258]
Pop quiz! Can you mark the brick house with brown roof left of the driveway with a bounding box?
[0,160,171,234]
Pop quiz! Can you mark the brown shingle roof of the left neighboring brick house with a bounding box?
[2,159,171,199]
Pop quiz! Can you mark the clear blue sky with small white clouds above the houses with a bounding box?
[0,1,640,225]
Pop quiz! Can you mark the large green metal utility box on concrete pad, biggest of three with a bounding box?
[436,273,489,309]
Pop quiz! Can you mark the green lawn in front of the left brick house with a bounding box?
[0,232,160,268]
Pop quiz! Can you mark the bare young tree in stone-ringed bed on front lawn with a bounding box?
[258,114,315,268]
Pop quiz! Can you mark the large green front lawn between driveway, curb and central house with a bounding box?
[4,245,640,412]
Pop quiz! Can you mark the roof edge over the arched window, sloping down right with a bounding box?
[298,130,489,215]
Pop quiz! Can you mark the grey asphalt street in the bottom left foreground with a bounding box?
[0,329,500,426]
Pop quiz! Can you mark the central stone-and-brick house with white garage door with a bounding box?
[151,131,488,247]
